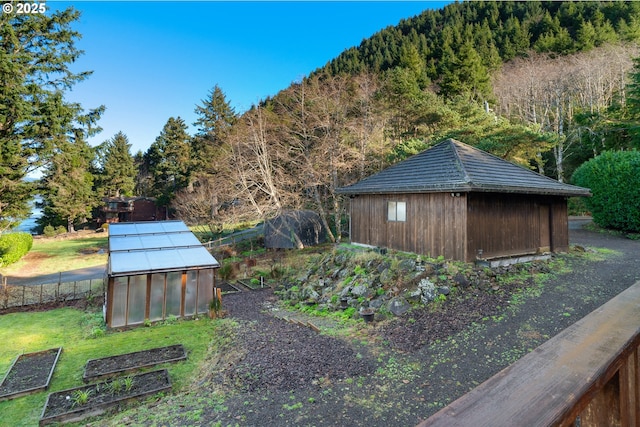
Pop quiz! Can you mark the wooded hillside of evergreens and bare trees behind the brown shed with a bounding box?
[0,1,640,239]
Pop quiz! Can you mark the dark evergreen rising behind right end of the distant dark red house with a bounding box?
[146,117,192,206]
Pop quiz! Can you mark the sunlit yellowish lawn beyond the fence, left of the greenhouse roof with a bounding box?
[0,235,108,276]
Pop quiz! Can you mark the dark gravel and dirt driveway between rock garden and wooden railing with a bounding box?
[107,224,640,427]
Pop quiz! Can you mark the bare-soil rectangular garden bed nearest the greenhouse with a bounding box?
[82,344,187,382]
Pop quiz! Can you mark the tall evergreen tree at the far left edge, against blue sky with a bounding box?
[0,8,102,230]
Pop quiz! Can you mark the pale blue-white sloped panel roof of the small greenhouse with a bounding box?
[108,221,220,276]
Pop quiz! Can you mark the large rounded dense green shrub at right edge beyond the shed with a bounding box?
[573,150,640,232]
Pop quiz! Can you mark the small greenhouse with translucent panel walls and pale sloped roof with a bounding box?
[105,221,220,328]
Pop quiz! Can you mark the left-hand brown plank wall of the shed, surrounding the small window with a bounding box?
[351,193,467,260]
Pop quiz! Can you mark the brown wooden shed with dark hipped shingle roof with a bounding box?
[337,139,591,262]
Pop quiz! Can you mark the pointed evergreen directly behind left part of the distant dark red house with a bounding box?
[97,132,136,197]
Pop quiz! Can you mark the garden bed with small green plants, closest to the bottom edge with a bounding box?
[40,369,171,426]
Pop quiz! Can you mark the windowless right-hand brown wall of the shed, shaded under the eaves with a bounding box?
[466,193,569,261]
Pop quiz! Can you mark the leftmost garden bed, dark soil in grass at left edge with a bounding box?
[0,347,62,400]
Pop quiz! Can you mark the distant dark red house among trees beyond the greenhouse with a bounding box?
[98,197,167,224]
